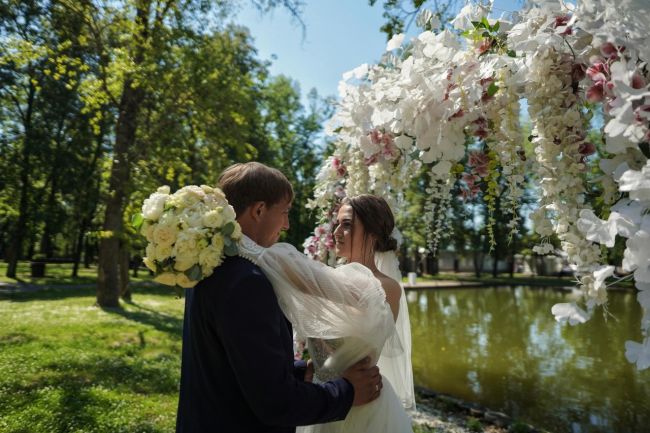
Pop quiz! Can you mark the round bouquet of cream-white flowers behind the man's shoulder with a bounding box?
[133,185,241,289]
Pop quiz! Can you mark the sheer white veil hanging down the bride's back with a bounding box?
[375,251,415,410]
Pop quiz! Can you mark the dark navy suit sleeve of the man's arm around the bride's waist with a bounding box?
[216,274,354,426]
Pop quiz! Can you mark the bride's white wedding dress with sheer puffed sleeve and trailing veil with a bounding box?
[239,236,415,433]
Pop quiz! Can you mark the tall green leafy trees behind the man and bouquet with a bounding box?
[0,0,328,286]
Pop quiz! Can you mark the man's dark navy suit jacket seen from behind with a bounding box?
[176,257,354,433]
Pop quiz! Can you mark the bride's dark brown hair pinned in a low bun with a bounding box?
[342,194,397,252]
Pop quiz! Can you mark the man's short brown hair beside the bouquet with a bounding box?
[219,162,293,215]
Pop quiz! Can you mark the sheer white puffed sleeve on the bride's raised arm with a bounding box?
[256,243,398,364]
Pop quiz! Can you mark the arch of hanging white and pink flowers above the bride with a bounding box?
[305,0,650,369]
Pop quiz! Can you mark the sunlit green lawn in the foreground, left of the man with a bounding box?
[0,288,184,433]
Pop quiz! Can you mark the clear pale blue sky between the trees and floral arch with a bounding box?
[234,0,521,103]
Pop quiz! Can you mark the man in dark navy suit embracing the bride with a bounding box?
[176,162,382,433]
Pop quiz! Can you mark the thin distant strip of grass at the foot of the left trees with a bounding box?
[0,261,151,285]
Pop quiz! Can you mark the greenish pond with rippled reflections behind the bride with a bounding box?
[407,287,650,433]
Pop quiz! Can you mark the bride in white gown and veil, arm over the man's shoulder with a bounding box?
[240,194,415,433]
